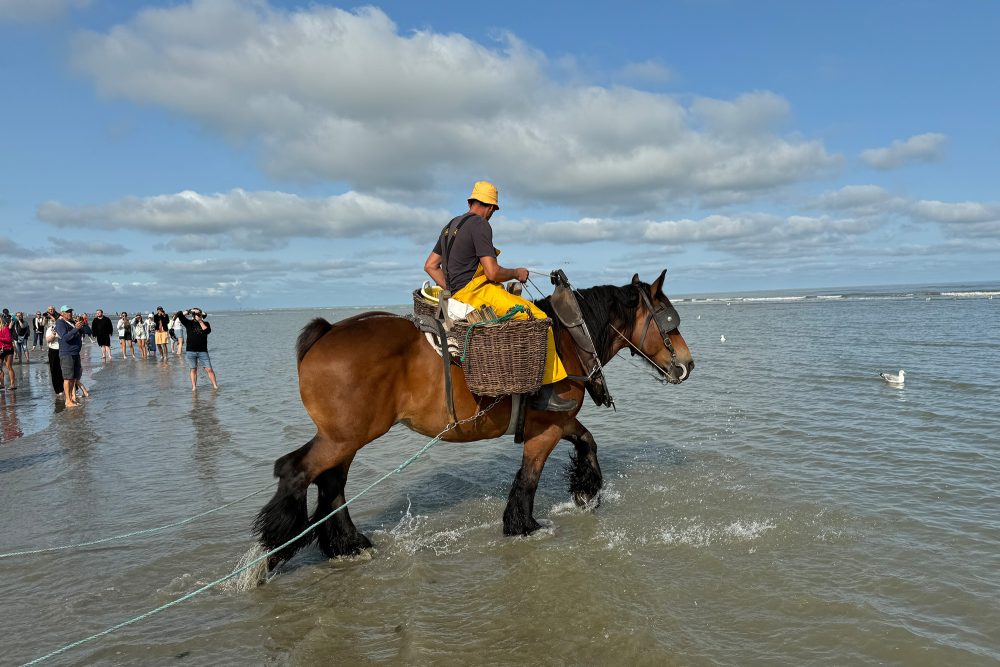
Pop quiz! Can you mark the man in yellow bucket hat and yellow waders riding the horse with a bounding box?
[424,181,577,412]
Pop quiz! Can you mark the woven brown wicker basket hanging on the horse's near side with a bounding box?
[449,315,552,396]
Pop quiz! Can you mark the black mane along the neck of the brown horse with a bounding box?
[535,283,649,364]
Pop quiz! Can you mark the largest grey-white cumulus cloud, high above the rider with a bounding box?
[72,0,840,215]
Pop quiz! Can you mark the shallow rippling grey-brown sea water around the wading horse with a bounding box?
[0,288,1000,665]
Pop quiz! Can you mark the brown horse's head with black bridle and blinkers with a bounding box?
[629,269,694,384]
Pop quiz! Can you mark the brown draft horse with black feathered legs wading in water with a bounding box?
[254,270,694,568]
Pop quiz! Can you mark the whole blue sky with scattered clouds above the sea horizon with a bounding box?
[0,0,1000,312]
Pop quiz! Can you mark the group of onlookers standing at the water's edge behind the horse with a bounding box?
[0,306,219,406]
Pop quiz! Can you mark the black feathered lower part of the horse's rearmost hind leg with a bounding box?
[253,440,316,569]
